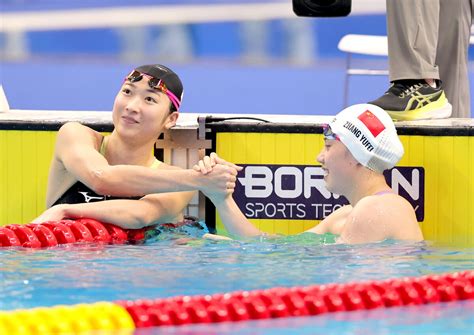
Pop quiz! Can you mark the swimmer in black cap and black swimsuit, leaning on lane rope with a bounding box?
[33,64,237,228]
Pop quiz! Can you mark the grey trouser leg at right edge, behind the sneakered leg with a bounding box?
[436,0,472,117]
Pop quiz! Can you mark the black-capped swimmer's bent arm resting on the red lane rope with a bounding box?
[33,192,195,229]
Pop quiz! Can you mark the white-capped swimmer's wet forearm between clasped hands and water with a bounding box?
[213,195,264,237]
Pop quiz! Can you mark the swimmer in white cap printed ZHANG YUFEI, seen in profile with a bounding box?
[194,104,423,243]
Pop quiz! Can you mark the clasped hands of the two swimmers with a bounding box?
[193,152,242,204]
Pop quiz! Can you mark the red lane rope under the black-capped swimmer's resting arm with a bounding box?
[0,219,154,248]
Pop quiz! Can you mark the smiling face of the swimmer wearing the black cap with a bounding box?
[112,78,179,140]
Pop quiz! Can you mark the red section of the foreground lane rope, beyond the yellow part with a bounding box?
[115,271,474,328]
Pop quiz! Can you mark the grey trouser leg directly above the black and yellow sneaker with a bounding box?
[387,0,438,81]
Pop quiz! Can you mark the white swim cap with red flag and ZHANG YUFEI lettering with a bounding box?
[329,104,404,173]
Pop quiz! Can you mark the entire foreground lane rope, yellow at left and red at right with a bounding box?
[0,270,474,334]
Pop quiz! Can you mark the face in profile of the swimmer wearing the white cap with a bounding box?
[316,139,358,195]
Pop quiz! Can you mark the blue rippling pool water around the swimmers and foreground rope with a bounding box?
[0,227,474,334]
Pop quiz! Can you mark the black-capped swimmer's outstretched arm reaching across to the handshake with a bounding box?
[55,122,233,197]
